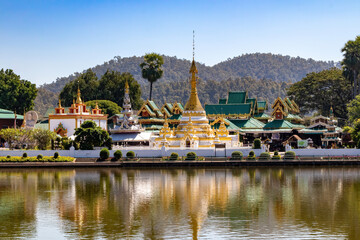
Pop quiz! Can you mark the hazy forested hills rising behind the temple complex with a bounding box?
[35,53,338,113]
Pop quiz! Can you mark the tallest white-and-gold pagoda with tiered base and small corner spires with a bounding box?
[150,59,238,148]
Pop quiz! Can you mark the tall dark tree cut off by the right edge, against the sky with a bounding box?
[341,36,360,98]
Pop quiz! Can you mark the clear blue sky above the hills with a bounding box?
[0,0,360,85]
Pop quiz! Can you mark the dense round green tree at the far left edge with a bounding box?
[0,69,37,113]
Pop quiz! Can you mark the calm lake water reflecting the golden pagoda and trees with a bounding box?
[0,167,360,240]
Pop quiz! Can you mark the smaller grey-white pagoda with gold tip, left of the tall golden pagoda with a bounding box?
[110,81,151,145]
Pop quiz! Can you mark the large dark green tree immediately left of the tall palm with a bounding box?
[98,70,142,109]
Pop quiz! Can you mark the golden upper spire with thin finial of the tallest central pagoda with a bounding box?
[185,30,204,112]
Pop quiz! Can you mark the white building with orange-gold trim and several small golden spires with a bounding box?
[48,89,107,137]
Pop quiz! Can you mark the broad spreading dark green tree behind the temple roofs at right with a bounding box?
[287,68,351,118]
